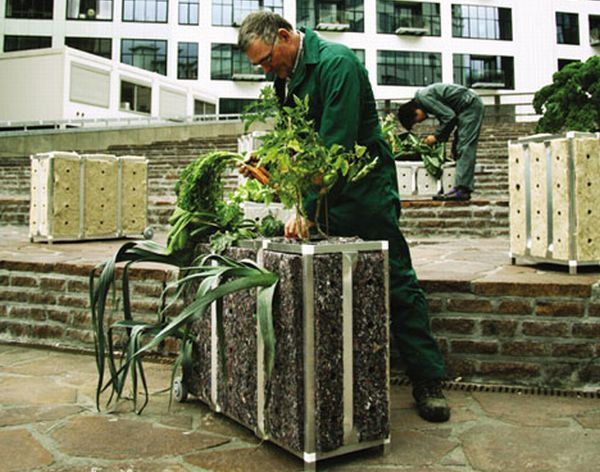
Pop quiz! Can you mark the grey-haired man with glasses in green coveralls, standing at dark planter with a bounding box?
[238,11,450,421]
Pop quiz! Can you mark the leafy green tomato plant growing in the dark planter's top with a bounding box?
[248,91,376,231]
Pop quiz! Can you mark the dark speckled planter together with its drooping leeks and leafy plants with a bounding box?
[92,86,390,463]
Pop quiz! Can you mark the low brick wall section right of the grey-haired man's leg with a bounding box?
[423,281,600,388]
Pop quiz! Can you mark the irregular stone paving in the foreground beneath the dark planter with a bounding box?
[0,344,600,472]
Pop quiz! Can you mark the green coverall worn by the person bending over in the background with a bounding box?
[415,84,483,192]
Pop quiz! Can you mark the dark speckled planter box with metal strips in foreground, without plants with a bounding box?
[175,240,390,469]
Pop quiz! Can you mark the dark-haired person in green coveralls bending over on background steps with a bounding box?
[398,84,483,201]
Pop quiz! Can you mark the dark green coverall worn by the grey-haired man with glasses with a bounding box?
[275,29,445,380]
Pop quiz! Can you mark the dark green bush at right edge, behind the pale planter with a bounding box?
[533,56,600,133]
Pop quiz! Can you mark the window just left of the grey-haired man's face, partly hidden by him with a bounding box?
[210,44,265,80]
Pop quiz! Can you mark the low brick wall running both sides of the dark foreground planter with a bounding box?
[0,262,600,388]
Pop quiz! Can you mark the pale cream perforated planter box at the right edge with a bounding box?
[509,132,600,274]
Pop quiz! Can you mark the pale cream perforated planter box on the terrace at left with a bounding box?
[29,152,151,242]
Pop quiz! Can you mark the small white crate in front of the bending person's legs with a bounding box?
[396,161,455,198]
